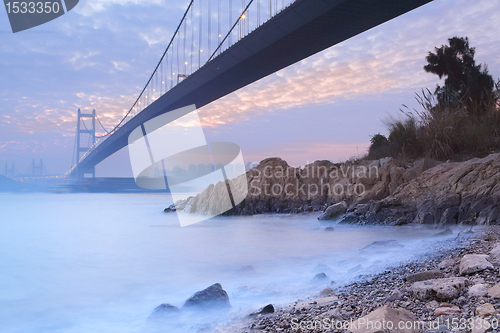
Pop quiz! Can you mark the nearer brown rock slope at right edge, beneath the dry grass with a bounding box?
[352,154,500,225]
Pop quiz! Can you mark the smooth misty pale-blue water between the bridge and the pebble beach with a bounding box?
[0,193,454,333]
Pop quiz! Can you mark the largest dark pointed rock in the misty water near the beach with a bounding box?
[182,283,231,310]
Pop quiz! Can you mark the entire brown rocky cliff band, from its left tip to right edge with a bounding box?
[170,154,500,225]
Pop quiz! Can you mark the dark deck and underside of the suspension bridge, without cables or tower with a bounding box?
[73,0,432,173]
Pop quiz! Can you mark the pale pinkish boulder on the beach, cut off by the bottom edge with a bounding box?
[349,306,421,333]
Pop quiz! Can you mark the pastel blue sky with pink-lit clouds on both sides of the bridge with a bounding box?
[0,0,500,176]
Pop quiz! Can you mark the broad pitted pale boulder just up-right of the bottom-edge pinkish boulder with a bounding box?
[411,277,469,301]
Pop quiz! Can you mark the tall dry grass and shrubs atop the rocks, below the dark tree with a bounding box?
[368,84,500,160]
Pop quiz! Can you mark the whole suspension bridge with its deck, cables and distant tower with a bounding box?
[67,0,432,177]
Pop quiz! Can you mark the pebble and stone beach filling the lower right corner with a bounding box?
[214,226,500,333]
